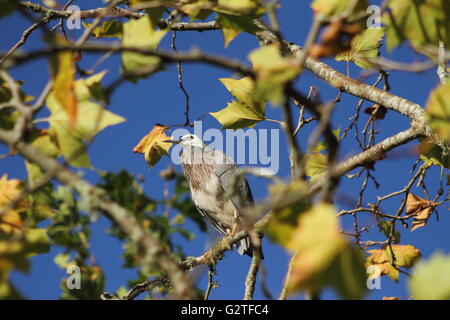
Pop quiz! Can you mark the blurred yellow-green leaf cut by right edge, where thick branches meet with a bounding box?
[426,82,450,143]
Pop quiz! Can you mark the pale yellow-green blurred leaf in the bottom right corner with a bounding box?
[408,252,450,300]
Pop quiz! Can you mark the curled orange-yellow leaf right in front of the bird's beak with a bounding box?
[133,124,172,168]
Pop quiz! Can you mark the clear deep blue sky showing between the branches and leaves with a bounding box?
[0,0,450,299]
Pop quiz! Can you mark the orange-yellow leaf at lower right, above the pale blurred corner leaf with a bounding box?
[366,244,421,282]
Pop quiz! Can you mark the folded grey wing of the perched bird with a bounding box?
[210,150,253,210]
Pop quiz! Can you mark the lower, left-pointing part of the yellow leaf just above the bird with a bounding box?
[209,101,266,129]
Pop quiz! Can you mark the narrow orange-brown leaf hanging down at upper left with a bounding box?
[52,51,77,125]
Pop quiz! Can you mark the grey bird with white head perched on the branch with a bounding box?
[165,134,254,256]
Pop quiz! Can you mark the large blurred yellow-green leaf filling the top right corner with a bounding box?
[383,0,450,51]
